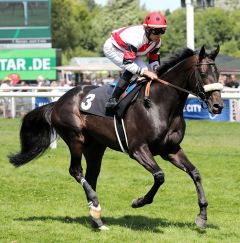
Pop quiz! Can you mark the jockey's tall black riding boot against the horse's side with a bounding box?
[106,71,133,110]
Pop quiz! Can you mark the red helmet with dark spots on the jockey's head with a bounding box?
[143,12,167,29]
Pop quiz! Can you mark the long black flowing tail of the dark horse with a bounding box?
[8,102,56,167]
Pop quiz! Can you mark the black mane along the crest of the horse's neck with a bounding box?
[157,48,196,76]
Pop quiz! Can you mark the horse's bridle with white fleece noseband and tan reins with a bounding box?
[144,56,223,106]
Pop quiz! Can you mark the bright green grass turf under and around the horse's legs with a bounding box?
[0,119,240,243]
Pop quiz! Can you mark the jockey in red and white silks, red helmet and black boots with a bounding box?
[103,12,167,110]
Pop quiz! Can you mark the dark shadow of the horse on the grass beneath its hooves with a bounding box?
[15,215,219,234]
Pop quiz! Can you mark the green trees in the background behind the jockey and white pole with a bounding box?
[52,0,240,59]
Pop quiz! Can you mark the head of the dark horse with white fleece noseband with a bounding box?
[193,46,223,114]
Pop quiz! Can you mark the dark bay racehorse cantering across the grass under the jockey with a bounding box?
[9,46,223,229]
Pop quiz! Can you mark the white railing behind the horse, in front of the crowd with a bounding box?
[0,86,240,118]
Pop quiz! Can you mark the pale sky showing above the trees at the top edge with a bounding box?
[95,0,181,11]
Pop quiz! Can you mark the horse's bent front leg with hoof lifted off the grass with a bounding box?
[130,145,164,208]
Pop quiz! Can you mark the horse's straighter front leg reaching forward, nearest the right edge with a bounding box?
[162,147,208,228]
